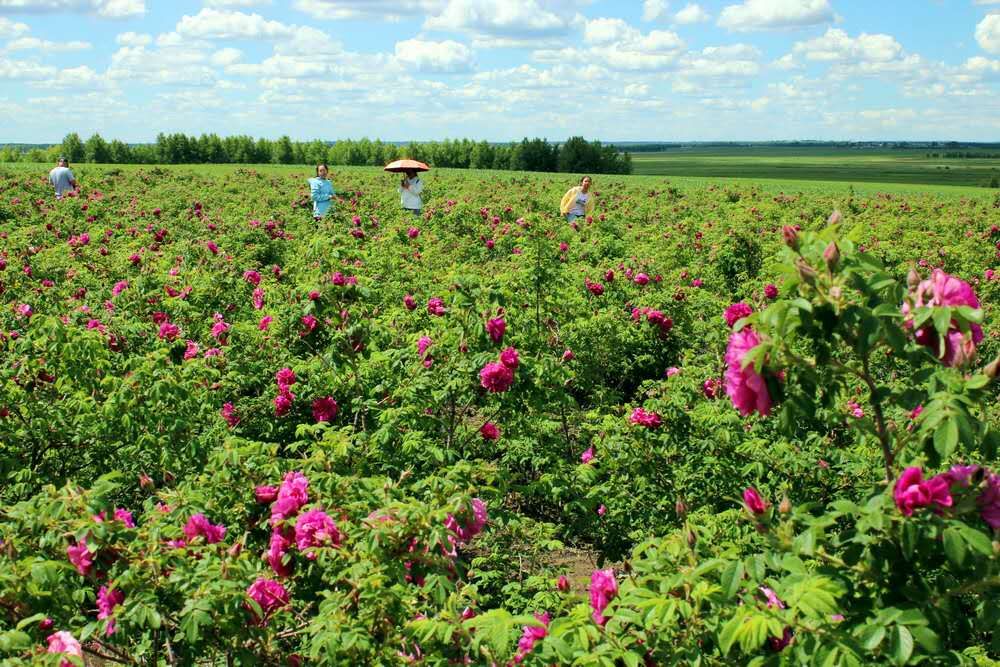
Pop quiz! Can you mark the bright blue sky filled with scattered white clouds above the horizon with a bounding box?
[0,0,1000,143]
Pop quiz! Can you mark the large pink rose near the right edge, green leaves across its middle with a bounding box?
[902,269,983,366]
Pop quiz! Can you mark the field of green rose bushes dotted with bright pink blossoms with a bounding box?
[0,165,1000,667]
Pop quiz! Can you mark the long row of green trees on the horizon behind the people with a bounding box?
[0,132,632,174]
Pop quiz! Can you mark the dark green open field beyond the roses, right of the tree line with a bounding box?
[632,146,1000,187]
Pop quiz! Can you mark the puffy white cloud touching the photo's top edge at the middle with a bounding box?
[424,0,579,40]
